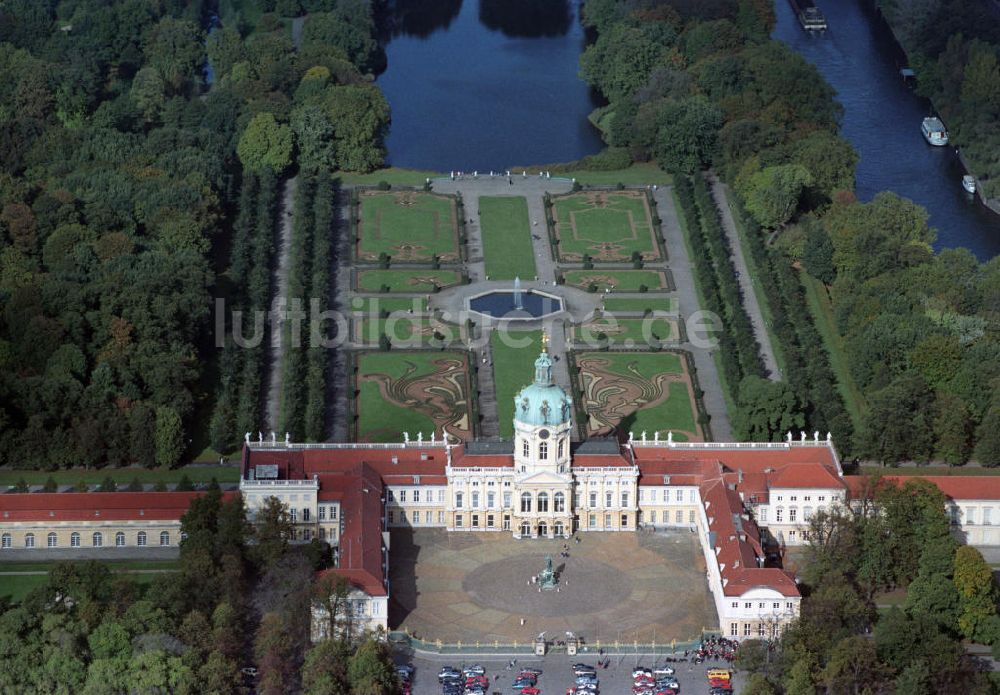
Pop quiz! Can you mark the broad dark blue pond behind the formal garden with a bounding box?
[378,0,603,171]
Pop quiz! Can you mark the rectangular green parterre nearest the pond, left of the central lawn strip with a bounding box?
[358,191,458,261]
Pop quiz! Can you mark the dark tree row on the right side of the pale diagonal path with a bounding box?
[734,203,854,453]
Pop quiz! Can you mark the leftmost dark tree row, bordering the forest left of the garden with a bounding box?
[210,169,278,452]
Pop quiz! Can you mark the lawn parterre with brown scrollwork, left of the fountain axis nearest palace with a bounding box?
[357,351,472,442]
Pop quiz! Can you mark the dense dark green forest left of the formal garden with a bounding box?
[0,0,389,470]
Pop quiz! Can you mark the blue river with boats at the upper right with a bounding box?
[773,0,1000,260]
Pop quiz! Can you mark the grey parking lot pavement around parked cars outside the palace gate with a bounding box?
[397,654,743,695]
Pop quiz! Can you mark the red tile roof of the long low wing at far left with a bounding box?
[0,492,233,521]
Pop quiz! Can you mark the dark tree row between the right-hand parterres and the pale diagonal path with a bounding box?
[674,177,764,402]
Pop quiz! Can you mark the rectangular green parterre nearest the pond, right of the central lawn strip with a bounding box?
[552,191,660,262]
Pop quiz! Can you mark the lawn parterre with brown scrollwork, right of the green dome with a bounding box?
[575,352,702,441]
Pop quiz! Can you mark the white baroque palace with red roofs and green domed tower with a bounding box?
[7,348,1000,639]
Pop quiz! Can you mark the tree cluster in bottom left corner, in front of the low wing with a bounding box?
[0,487,398,695]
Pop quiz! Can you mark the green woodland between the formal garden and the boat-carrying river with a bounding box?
[580,0,1000,465]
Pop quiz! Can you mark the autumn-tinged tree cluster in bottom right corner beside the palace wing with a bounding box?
[736,477,1000,695]
